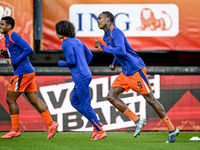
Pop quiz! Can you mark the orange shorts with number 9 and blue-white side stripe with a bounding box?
[111,67,152,94]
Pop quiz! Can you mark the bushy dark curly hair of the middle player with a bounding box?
[56,20,75,37]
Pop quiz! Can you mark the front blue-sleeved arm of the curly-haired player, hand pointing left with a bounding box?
[58,43,76,67]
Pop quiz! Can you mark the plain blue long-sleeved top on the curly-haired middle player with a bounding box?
[58,37,93,83]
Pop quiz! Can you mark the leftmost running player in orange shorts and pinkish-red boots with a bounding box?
[0,16,58,139]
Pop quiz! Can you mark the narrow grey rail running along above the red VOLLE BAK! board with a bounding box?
[0,65,200,75]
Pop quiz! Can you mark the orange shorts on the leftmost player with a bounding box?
[8,72,37,93]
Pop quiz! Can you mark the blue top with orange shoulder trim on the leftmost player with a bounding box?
[4,30,35,75]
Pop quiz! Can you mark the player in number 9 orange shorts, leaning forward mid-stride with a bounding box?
[95,11,179,143]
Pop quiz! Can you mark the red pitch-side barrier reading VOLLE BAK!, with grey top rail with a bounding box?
[0,64,200,132]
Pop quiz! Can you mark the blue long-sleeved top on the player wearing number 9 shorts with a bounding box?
[100,25,145,76]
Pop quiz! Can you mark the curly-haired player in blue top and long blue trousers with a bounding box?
[55,20,107,140]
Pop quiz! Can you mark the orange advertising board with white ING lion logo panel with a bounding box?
[41,0,200,51]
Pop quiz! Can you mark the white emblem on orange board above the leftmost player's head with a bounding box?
[0,1,14,18]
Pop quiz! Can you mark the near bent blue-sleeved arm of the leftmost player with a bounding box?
[11,33,33,65]
